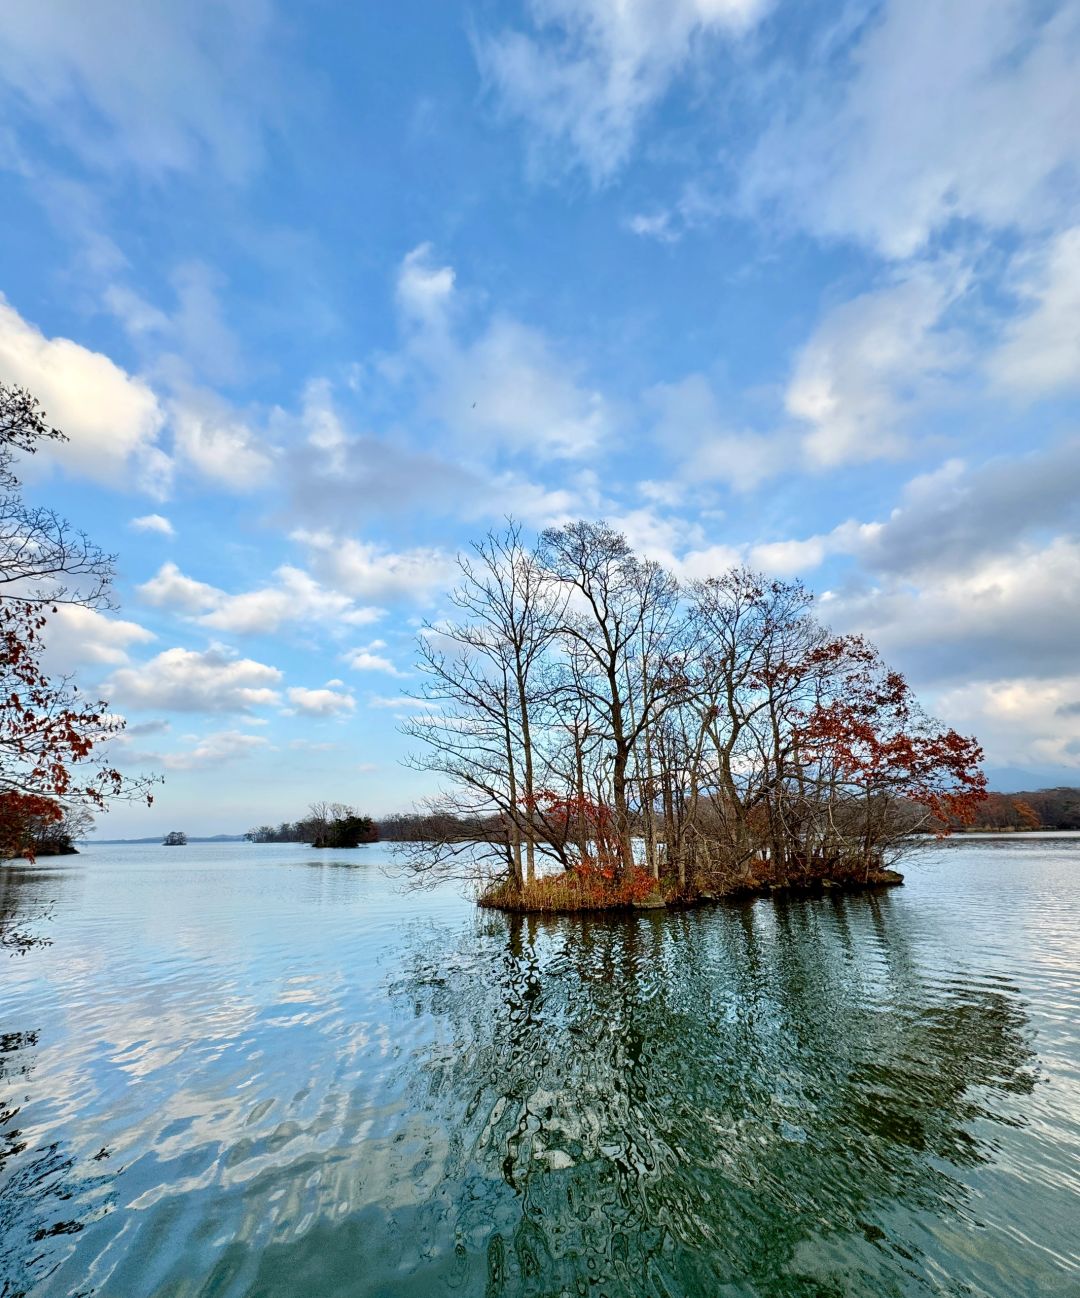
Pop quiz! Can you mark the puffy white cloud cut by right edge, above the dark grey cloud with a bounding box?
[988,226,1080,396]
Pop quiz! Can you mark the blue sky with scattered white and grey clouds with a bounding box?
[0,0,1080,836]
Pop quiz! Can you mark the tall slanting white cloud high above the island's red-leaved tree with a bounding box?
[784,263,968,467]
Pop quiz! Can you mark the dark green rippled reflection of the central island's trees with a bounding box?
[395,897,1035,1295]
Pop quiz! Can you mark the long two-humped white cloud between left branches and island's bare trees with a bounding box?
[138,562,383,635]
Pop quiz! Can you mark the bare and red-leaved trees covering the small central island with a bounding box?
[399,522,985,910]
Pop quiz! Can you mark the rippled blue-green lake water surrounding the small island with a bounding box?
[0,836,1080,1298]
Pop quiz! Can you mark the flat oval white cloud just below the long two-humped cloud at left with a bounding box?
[105,648,282,713]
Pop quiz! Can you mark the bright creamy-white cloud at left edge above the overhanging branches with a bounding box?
[0,295,165,487]
